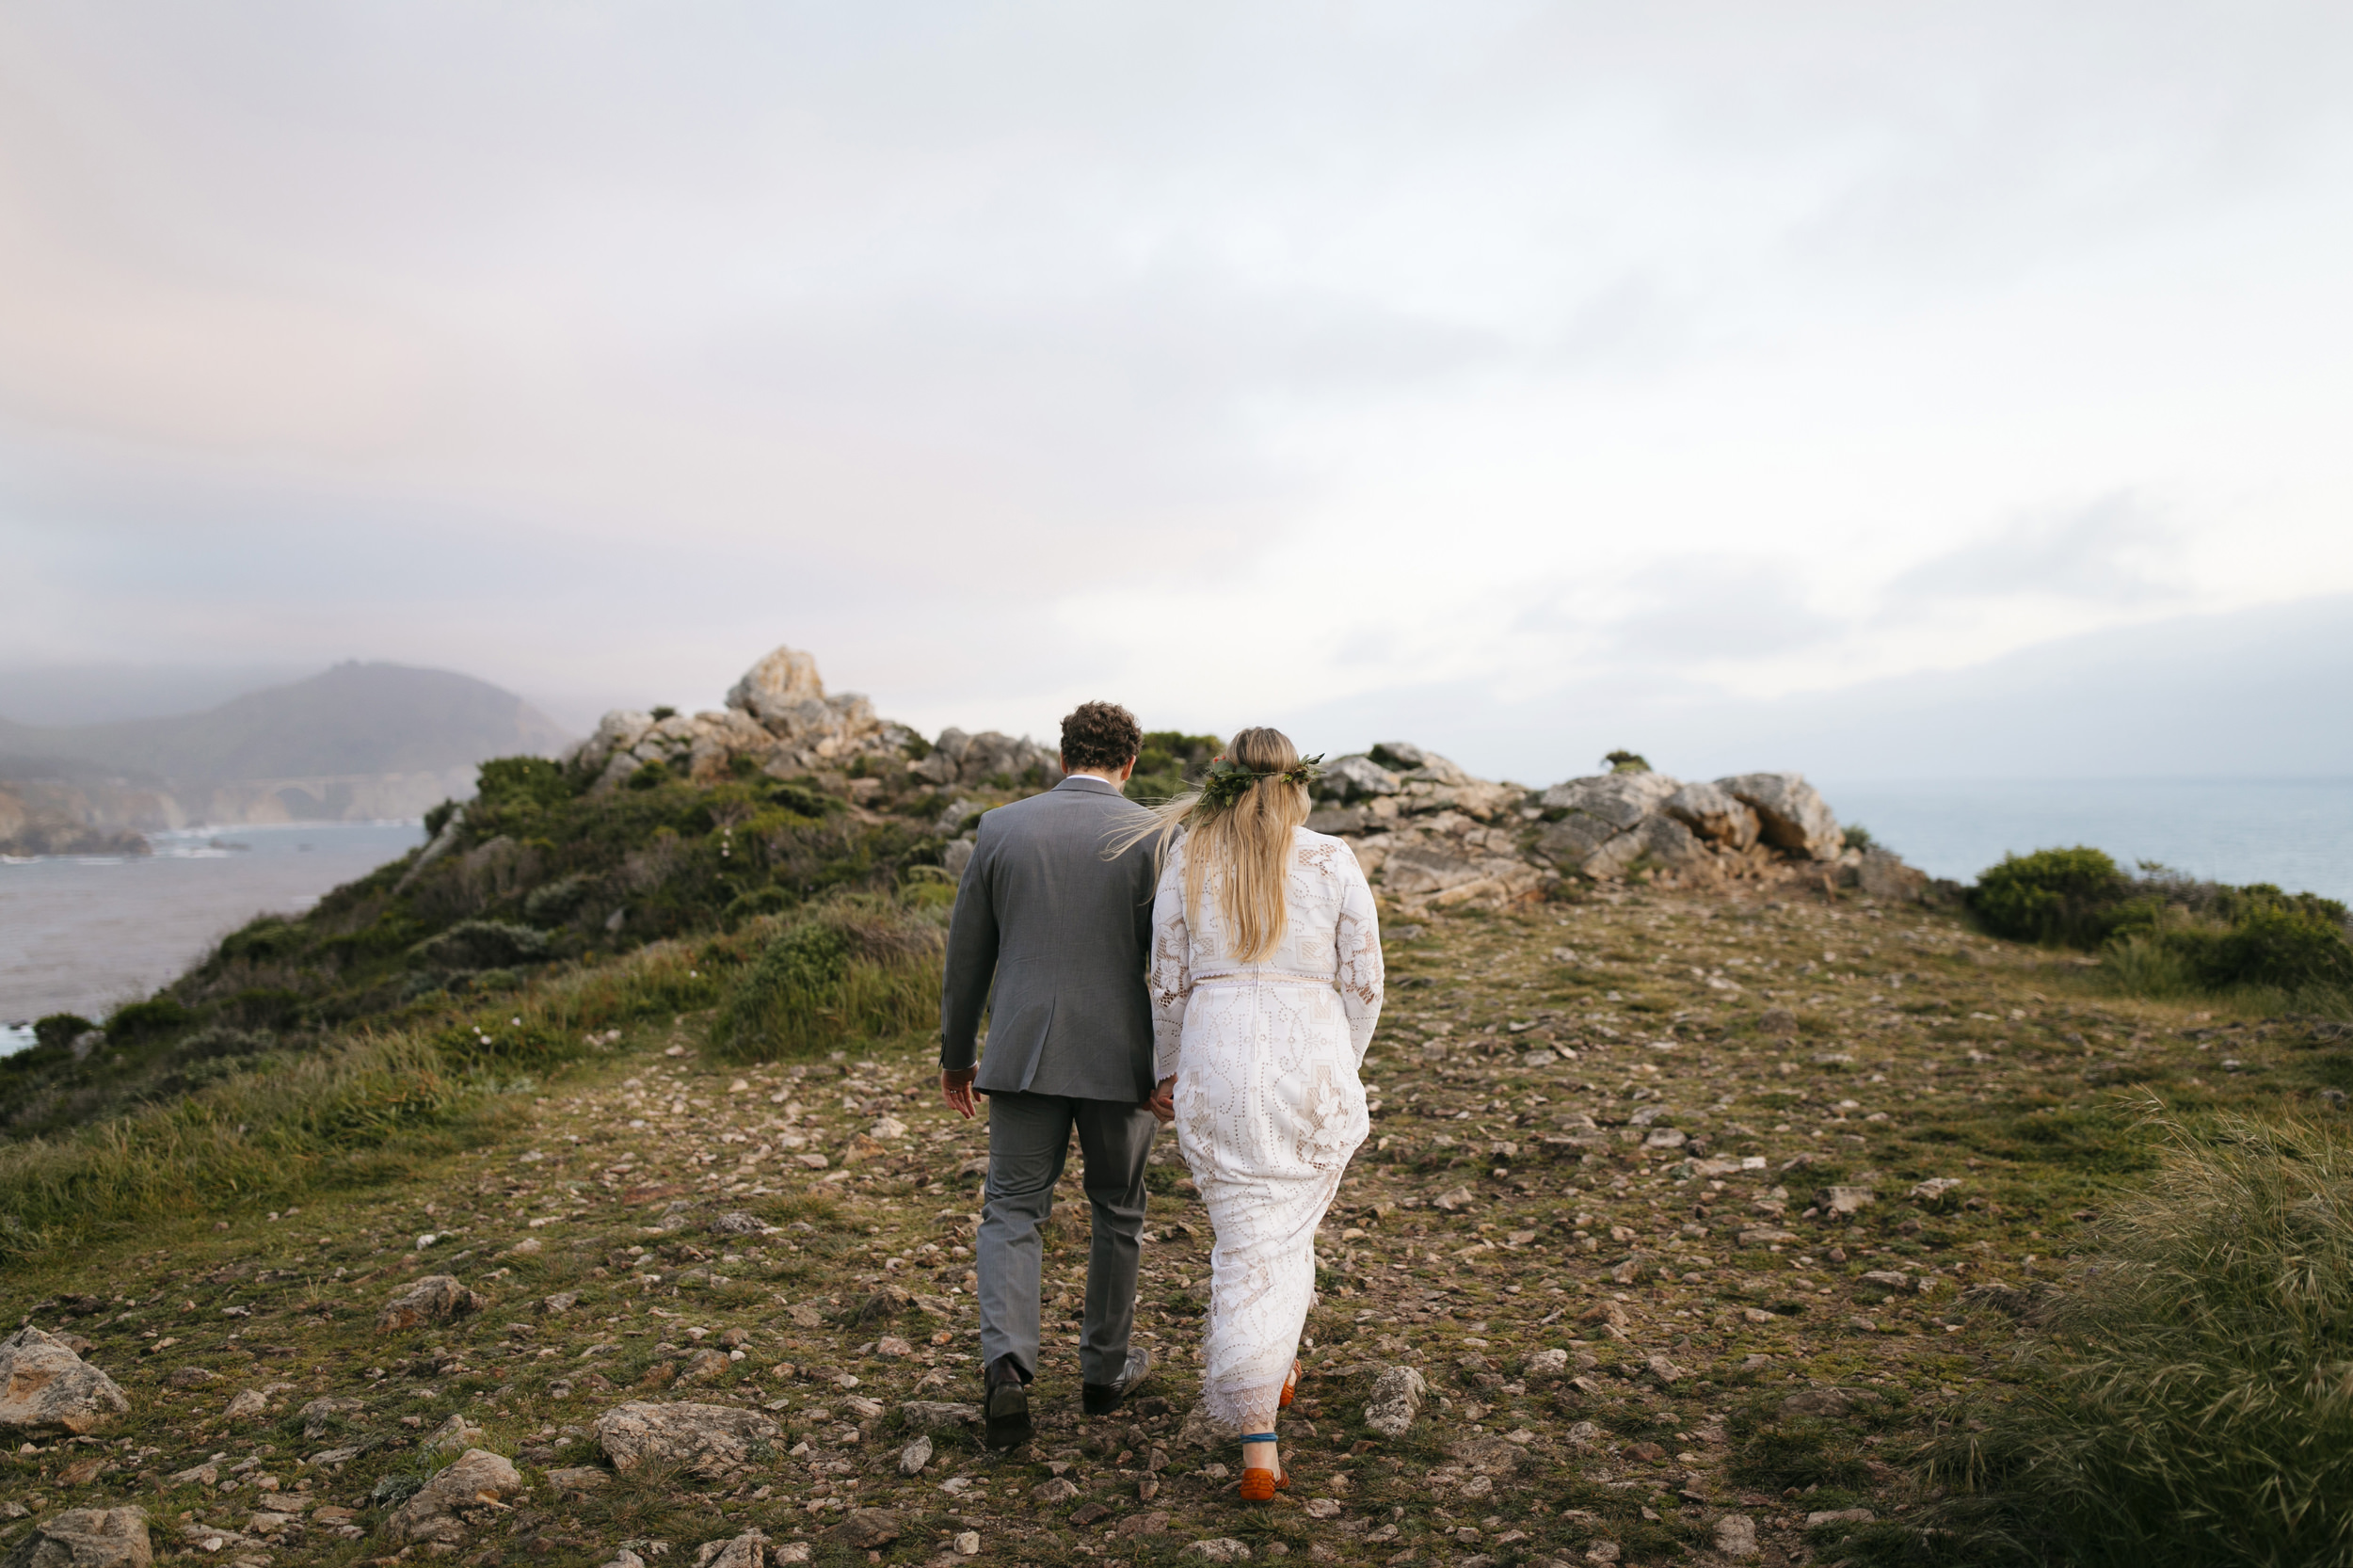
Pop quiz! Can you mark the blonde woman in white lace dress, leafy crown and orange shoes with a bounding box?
[1120,729,1382,1502]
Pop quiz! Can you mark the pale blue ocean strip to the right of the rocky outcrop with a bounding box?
[1817,779,2353,902]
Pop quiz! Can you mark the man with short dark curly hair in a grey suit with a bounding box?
[939,701,1158,1448]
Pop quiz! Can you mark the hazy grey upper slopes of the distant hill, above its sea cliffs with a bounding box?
[0,662,572,784]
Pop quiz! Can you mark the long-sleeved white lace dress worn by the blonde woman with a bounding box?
[1148,829,1382,1433]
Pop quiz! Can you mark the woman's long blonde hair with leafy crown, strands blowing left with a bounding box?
[1111,728,1308,963]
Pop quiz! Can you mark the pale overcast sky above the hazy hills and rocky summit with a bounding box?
[0,0,2353,776]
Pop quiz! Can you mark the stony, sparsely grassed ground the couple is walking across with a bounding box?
[0,886,2348,1568]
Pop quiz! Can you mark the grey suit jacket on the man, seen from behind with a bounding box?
[939,775,1158,1104]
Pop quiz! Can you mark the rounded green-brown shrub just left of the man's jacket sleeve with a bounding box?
[713,895,946,1062]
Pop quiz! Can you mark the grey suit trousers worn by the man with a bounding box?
[974,1093,1158,1384]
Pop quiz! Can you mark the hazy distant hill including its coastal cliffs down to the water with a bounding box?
[0,662,569,855]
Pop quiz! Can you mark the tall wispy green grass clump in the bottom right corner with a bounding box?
[1929,1099,2353,1568]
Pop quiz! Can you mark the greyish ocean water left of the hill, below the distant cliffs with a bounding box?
[0,822,424,1055]
